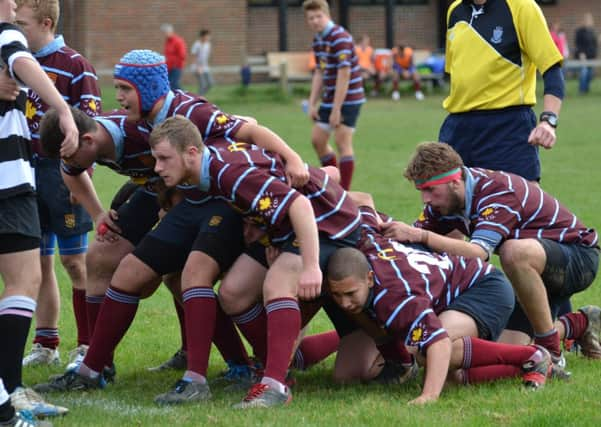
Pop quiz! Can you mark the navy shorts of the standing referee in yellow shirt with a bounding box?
[438,106,541,181]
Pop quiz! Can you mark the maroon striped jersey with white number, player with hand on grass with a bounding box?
[358,207,494,351]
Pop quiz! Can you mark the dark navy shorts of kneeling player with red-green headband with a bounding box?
[507,239,599,336]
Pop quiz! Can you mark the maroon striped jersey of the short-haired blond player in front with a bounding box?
[200,144,359,243]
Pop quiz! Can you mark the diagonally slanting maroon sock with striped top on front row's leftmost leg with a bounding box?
[83,286,140,372]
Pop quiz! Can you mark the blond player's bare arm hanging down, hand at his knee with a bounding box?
[288,195,322,300]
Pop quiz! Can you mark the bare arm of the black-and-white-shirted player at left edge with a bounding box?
[12,56,79,157]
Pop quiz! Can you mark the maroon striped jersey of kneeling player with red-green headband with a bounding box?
[414,168,599,252]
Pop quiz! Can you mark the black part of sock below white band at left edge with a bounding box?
[0,314,31,394]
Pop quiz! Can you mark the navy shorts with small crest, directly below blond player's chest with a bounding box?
[133,200,244,275]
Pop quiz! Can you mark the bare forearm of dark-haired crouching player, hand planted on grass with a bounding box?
[409,337,452,405]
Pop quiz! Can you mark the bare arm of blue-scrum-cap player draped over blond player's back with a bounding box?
[236,123,309,187]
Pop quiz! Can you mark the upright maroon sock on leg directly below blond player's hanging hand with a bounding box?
[265,298,300,384]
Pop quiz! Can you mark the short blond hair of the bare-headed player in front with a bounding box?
[148,115,204,153]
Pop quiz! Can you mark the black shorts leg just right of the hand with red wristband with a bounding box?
[116,187,160,246]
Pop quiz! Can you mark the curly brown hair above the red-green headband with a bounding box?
[404,142,463,182]
